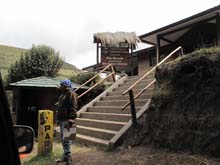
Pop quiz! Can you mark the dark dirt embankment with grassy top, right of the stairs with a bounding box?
[122,48,220,157]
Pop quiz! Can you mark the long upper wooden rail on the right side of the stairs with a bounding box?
[122,46,182,95]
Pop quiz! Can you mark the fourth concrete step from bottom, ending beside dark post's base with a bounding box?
[80,112,131,122]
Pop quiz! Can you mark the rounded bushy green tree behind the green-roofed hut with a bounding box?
[7,45,64,83]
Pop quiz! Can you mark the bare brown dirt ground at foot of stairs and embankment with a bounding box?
[72,147,220,165]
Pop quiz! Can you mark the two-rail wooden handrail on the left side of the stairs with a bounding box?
[74,64,115,99]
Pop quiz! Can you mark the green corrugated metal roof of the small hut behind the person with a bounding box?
[9,76,88,88]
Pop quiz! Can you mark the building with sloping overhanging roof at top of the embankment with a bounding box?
[134,5,220,75]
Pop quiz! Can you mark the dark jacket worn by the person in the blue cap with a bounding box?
[57,88,77,121]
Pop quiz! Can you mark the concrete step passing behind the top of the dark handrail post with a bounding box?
[101,94,152,101]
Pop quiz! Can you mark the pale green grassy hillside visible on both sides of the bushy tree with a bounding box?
[0,45,80,78]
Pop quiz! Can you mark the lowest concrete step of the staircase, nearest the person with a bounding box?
[76,133,109,147]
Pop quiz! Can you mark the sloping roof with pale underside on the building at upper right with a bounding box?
[139,5,220,46]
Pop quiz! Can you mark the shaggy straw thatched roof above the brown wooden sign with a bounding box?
[94,32,141,46]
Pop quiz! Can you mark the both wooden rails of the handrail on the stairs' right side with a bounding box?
[121,46,183,110]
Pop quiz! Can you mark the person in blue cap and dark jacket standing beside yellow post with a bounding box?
[56,79,77,164]
